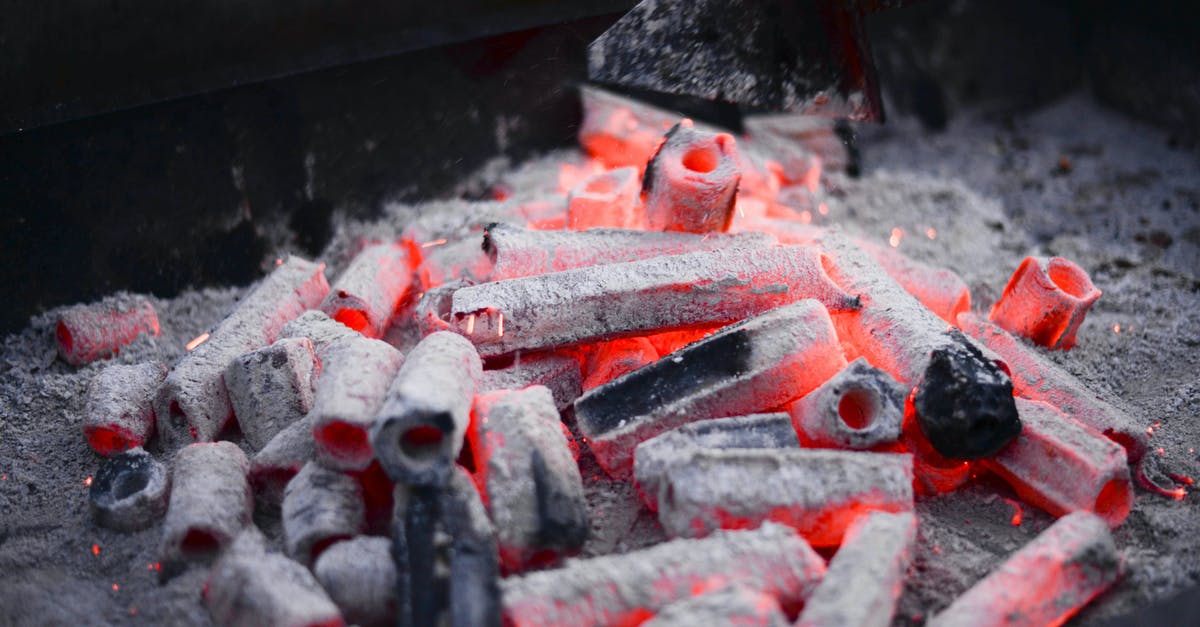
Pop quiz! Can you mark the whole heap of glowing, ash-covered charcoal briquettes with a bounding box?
[56,89,1189,626]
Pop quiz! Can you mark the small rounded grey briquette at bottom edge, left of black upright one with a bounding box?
[312,536,396,627]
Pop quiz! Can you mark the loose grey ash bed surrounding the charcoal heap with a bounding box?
[0,95,1200,625]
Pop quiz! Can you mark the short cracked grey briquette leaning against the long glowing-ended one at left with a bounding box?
[224,338,320,450]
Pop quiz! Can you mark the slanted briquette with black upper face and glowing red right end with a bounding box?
[575,300,846,478]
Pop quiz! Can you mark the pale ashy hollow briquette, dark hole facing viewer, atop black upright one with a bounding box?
[371,332,484,485]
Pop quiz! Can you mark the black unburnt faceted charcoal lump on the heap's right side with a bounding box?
[913,329,1021,459]
